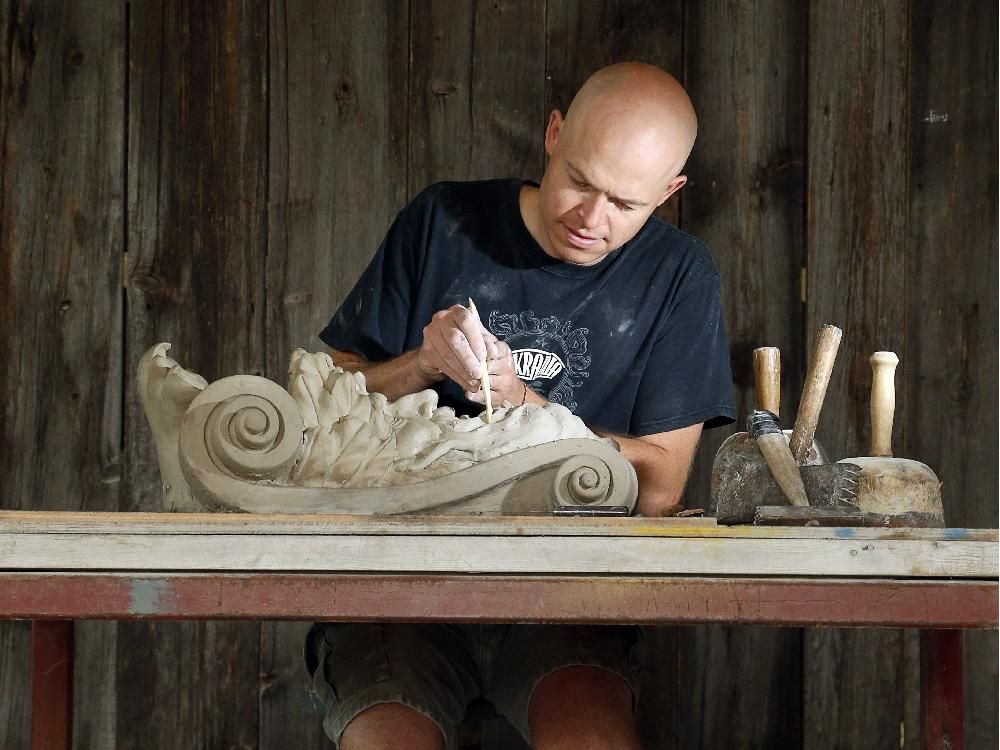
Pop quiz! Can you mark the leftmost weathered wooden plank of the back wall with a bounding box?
[0,1,125,748]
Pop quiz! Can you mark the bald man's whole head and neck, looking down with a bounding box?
[520,63,698,265]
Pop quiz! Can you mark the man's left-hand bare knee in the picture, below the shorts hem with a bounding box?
[339,703,445,750]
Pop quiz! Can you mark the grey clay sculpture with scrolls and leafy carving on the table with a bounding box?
[138,343,638,515]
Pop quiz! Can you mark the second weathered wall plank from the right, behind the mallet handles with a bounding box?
[803,0,917,750]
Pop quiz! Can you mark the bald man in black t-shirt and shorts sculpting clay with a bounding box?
[308,63,735,750]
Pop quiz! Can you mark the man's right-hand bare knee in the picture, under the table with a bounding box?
[528,666,639,750]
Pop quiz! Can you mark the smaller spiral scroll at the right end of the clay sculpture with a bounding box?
[552,443,638,510]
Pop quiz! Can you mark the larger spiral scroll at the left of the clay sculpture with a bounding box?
[179,375,305,507]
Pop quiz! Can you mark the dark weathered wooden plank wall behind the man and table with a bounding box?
[0,0,998,748]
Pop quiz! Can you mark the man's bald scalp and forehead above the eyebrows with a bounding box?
[562,63,698,189]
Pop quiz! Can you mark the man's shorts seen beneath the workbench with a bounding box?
[306,623,643,743]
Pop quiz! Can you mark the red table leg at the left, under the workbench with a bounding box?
[31,620,73,750]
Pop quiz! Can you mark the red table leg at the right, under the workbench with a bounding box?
[920,630,963,750]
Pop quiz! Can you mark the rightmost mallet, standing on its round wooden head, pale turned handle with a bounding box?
[839,352,945,527]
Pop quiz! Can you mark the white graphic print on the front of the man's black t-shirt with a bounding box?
[488,310,590,411]
